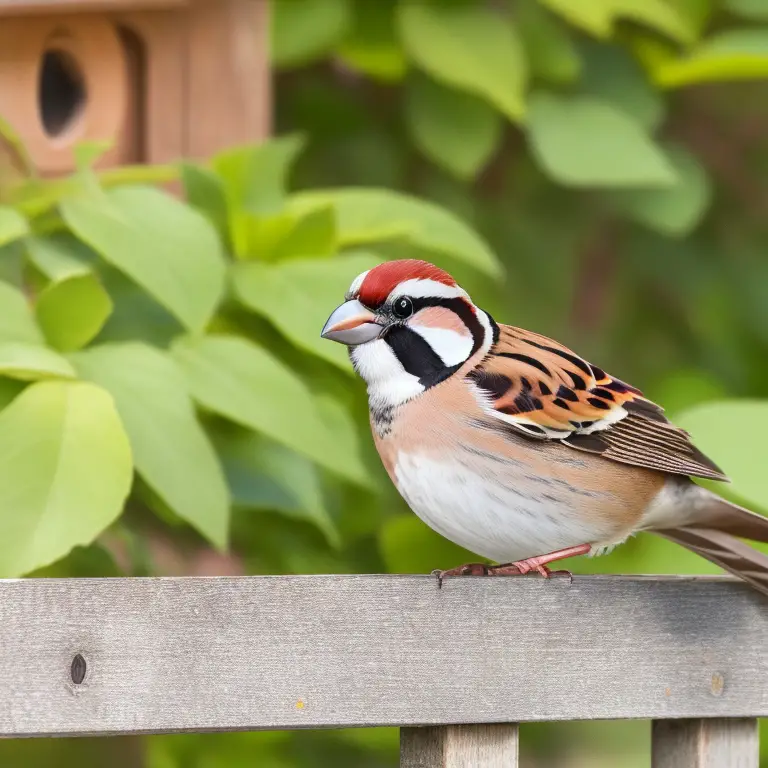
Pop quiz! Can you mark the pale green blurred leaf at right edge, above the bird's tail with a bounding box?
[676,400,768,511]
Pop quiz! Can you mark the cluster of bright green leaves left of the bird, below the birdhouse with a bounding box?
[0,127,499,575]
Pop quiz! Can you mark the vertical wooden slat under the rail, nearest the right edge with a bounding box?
[651,718,759,768]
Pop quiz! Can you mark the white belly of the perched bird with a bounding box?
[395,452,623,562]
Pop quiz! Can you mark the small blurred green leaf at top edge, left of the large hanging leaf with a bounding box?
[336,0,408,83]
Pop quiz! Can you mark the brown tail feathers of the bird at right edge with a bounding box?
[653,494,768,595]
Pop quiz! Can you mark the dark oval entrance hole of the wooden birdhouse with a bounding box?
[38,48,88,139]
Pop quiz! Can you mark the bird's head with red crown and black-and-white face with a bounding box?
[322,259,497,408]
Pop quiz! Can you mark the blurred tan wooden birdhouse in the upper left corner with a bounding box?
[0,0,270,176]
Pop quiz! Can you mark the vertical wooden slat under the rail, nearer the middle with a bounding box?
[400,724,518,768]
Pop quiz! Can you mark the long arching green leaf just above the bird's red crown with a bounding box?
[289,187,502,277]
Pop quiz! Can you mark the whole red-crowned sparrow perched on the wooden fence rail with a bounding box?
[321,259,768,594]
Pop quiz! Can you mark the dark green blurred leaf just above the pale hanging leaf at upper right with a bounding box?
[580,43,664,131]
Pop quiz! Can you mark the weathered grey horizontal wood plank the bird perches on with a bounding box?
[0,576,768,736]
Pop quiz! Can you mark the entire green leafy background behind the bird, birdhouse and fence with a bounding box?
[0,0,768,768]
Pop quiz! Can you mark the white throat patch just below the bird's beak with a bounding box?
[351,339,424,409]
